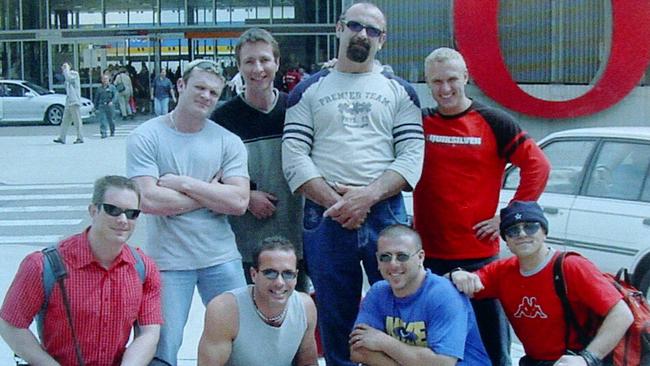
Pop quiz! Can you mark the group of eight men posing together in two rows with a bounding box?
[0,3,631,366]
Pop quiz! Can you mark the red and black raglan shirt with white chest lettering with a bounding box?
[413,101,550,260]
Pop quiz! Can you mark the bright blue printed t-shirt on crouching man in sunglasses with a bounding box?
[355,270,490,366]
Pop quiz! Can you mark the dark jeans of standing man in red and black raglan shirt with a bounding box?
[424,257,512,366]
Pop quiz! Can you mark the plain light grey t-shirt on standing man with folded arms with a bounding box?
[126,116,248,270]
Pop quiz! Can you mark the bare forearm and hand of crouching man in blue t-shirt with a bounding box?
[350,324,458,366]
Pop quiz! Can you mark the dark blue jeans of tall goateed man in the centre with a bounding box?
[303,194,407,365]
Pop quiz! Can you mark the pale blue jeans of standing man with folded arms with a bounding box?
[150,260,246,366]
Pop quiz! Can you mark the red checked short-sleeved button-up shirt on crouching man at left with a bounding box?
[0,230,163,365]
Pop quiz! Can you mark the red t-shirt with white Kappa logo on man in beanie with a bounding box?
[475,253,623,360]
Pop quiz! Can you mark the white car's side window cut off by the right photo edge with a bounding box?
[586,142,650,200]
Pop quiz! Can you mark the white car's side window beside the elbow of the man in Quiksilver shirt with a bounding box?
[503,140,596,194]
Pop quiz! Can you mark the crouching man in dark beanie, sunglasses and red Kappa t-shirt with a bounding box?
[449,201,633,366]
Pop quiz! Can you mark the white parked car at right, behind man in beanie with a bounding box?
[500,127,650,294]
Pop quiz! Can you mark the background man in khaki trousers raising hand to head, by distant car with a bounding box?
[54,62,84,144]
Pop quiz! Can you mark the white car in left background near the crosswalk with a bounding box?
[0,80,94,125]
